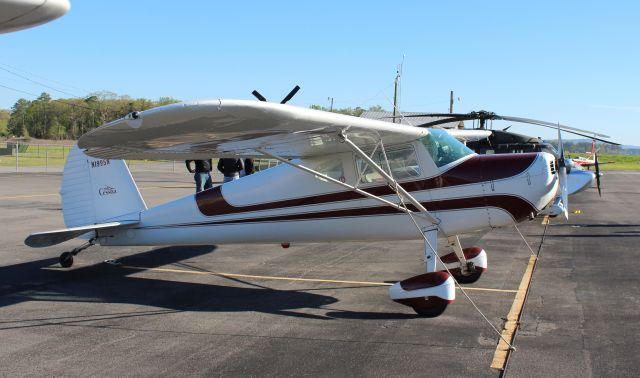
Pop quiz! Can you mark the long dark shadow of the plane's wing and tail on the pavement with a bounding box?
[0,246,337,320]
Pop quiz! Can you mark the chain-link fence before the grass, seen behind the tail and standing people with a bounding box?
[0,142,279,177]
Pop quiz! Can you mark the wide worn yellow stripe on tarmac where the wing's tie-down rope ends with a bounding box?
[491,256,538,370]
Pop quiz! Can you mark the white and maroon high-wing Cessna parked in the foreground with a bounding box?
[25,99,568,317]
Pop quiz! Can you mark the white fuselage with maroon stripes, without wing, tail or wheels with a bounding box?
[98,142,557,245]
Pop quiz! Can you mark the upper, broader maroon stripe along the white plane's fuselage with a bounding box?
[196,153,537,216]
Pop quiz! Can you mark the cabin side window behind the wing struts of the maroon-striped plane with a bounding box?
[356,145,420,183]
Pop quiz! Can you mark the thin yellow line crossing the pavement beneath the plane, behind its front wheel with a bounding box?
[119,265,517,293]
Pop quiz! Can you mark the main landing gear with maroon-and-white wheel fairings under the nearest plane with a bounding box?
[389,229,487,318]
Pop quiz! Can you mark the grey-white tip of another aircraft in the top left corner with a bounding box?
[0,0,71,33]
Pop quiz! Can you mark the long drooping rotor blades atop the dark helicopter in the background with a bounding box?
[387,110,619,145]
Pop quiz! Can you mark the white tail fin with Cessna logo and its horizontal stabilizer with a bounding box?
[25,146,147,247]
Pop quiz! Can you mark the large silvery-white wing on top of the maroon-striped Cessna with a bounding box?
[78,100,429,160]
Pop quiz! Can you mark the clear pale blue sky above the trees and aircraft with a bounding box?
[0,0,640,145]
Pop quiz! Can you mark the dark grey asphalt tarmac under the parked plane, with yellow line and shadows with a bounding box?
[0,171,640,377]
